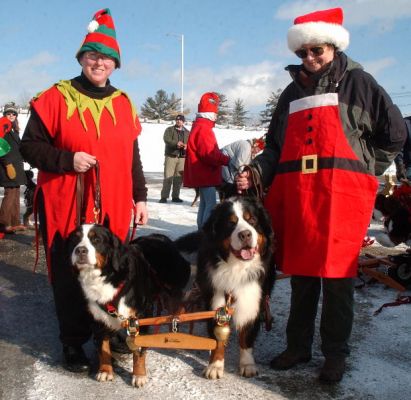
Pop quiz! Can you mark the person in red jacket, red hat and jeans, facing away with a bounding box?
[184,93,230,229]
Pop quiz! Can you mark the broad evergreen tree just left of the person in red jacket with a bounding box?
[141,89,180,121]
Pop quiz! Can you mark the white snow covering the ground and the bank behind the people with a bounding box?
[0,114,411,400]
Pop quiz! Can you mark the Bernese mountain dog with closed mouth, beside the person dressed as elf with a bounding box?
[68,225,190,387]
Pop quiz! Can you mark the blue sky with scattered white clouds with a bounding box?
[0,0,411,116]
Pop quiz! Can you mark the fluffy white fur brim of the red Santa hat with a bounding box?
[287,22,350,52]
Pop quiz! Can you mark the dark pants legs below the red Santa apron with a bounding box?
[287,276,354,357]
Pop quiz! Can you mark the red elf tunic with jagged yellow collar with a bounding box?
[31,81,141,274]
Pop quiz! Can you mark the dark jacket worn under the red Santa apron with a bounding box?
[252,53,406,187]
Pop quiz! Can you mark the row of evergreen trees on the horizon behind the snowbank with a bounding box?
[140,89,282,126]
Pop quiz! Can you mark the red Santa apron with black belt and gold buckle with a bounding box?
[265,93,378,278]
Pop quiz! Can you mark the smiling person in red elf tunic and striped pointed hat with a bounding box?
[21,8,148,372]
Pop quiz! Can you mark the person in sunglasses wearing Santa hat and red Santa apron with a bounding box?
[236,8,405,382]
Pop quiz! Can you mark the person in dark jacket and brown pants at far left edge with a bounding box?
[0,102,26,234]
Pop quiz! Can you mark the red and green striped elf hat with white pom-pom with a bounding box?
[76,8,120,68]
